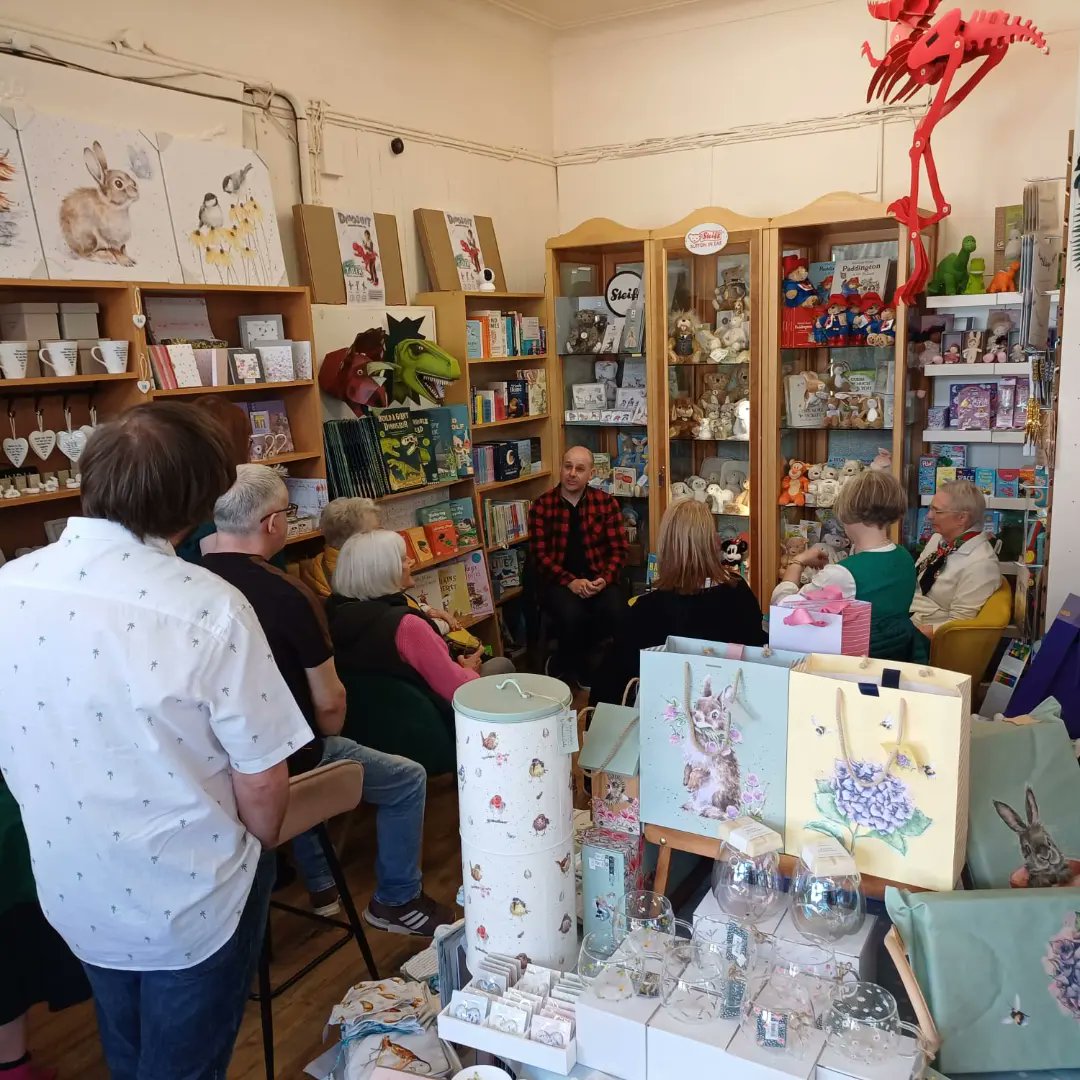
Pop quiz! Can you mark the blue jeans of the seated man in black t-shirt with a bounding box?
[293,735,428,907]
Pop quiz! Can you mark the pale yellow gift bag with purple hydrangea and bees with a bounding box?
[785,653,971,890]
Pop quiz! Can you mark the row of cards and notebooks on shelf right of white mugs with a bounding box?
[148,341,311,390]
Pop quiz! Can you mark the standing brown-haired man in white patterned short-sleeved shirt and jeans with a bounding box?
[0,402,311,1078]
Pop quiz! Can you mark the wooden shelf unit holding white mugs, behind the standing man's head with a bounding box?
[0,279,326,558]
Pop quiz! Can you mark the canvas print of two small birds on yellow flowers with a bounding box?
[158,141,288,285]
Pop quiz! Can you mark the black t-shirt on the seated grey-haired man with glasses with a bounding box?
[202,552,334,774]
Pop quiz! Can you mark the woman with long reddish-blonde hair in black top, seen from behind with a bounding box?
[590,499,769,705]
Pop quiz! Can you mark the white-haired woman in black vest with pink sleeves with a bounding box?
[326,529,514,715]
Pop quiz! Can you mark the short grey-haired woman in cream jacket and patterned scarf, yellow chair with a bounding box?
[912,480,1001,637]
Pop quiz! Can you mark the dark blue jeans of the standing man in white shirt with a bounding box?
[83,852,276,1080]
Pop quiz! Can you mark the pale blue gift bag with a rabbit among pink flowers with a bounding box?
[637,637,805,837]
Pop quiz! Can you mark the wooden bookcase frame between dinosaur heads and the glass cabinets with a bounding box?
[414,291,559,653]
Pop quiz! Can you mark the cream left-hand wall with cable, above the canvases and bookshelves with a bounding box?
[0,0,557,295]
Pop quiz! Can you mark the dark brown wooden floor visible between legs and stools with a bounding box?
[30,777,461,1080]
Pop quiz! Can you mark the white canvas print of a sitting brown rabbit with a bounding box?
[19,112,180,281]
